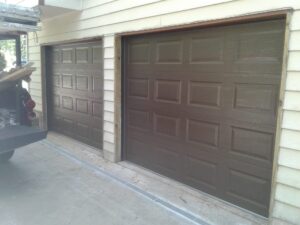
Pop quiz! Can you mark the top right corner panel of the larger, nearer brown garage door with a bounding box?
[233,23,284,74]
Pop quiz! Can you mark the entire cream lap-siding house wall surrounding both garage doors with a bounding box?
[29,0,300,224]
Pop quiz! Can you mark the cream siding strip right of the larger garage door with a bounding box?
[273,7,300,224]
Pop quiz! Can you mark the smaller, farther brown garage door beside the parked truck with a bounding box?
[47,42,103,148]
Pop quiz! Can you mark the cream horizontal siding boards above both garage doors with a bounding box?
[28,0,300,42]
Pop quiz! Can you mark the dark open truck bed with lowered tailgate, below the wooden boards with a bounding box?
[0,78,46,162]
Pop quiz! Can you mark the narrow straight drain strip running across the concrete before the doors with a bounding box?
[41,140,210,225]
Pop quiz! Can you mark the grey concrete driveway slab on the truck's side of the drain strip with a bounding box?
[0,141,195,225]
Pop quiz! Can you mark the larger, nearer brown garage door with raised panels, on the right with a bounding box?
[124,20,285,216]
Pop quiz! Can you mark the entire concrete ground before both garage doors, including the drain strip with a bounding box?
[0,133,292,225]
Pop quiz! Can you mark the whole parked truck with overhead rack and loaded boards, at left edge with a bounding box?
[0,3,46,162]
